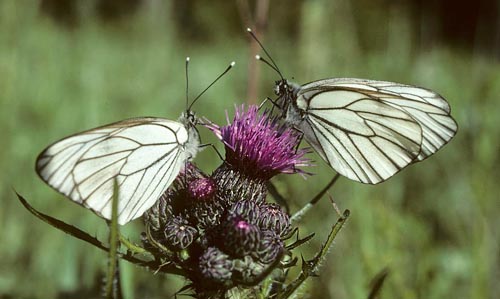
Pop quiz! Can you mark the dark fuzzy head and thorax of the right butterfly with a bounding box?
[274,79,304,125]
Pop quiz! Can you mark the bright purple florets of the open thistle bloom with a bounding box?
[208,105,309,180]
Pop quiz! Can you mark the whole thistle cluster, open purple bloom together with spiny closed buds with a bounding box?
[143,106,308,298]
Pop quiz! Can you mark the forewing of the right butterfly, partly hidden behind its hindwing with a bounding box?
[299,78,457,161]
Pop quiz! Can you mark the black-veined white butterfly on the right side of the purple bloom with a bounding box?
[249,30,457,184]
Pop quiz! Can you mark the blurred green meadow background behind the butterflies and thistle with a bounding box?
[0,0,500,299]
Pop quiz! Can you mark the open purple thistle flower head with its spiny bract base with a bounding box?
[207,106,309,203]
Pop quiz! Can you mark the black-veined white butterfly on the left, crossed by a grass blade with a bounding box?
[36,58,234,225]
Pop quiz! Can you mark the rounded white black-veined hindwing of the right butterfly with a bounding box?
[297,88,422,184]
